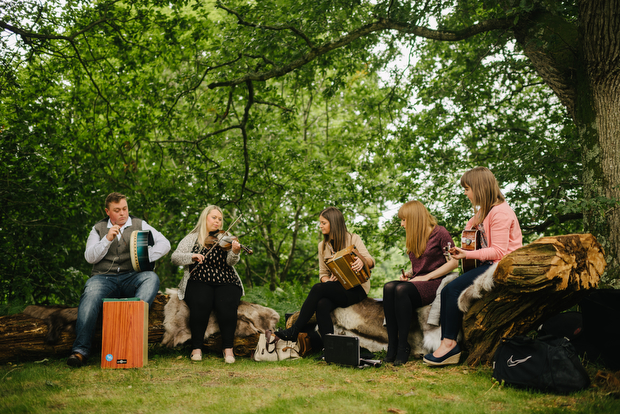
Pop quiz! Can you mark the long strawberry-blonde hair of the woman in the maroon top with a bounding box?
[398,200,437,257]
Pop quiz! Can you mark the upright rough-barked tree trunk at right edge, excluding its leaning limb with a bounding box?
[577,0,620,288]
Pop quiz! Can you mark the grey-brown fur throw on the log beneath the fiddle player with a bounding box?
[161,289,280,347]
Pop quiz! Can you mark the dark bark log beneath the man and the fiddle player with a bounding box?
[0,295,259,363]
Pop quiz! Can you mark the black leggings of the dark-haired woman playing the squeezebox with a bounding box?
[294,282,366,337]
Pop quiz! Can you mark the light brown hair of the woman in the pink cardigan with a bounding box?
[461,167,505,225]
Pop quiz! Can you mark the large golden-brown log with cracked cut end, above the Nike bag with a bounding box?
[463,234,606,366]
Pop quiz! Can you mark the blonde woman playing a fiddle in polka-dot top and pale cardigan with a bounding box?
[171,206,244,364]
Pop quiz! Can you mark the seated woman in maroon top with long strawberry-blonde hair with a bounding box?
[383,200,459,365]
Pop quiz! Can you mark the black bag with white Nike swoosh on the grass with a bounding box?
[493,336,590,394]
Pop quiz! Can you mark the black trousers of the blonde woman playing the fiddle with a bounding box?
[185,280,241,349]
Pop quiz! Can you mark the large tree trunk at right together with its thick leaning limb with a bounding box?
[504,0,620,288]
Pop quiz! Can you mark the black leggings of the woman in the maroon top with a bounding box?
[383,281,422,349]
